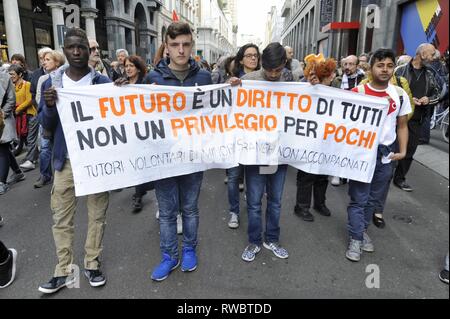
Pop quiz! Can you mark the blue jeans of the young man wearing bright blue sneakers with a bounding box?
[155,172,203,258]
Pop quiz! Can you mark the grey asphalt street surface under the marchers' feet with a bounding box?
[0,136,449,299]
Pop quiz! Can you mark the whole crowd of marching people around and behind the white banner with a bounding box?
[0,22,448,294]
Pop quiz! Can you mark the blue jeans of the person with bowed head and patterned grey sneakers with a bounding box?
[245,165,287,246]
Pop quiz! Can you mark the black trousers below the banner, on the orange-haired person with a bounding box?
[297,170,328,208]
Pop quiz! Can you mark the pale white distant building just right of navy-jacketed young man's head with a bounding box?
[197,0,234,63]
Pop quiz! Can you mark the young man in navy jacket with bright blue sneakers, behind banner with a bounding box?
[145,22,212,281]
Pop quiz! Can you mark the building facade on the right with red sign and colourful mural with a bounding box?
[282,0,449,59]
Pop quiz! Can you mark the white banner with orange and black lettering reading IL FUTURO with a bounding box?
[57,81,388,196]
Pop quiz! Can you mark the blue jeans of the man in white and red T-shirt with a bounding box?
[347,150,393,240]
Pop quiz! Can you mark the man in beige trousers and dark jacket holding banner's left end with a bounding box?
[39,28,110,293]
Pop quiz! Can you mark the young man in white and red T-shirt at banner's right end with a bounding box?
[346,49,412,262]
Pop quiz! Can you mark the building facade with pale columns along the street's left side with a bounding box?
[0,0,200,68]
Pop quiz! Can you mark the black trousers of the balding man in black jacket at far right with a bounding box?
[394,120,422,184]
